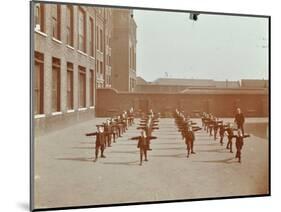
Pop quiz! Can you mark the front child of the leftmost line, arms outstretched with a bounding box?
[86,125,105,162]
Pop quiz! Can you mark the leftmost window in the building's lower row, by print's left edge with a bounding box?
[34,52,44,114]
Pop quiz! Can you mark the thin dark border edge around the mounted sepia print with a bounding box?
[29,0,271,211]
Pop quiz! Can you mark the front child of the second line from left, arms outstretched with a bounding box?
[131,130,157,166]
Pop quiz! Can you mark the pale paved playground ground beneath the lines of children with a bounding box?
[34,118,269,208]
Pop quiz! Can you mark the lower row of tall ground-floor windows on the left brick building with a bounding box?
[34,52,95,114]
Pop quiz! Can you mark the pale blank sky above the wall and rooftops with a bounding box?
[134,10,268,81]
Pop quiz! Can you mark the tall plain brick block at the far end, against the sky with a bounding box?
[112,9,137,91]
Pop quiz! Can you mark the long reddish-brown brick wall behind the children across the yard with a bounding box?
[96,89,268,117]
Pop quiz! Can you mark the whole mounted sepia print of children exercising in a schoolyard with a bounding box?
[30,1,270,211]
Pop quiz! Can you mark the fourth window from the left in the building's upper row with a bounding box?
[78,8,86,52]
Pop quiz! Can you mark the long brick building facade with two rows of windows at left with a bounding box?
[33,3,118,132]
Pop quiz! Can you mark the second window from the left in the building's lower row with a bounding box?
[52,57,60,112]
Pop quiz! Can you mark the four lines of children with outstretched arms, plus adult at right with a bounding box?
[86,108,249,165]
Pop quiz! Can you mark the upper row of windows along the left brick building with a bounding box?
[34,3,106,57]
